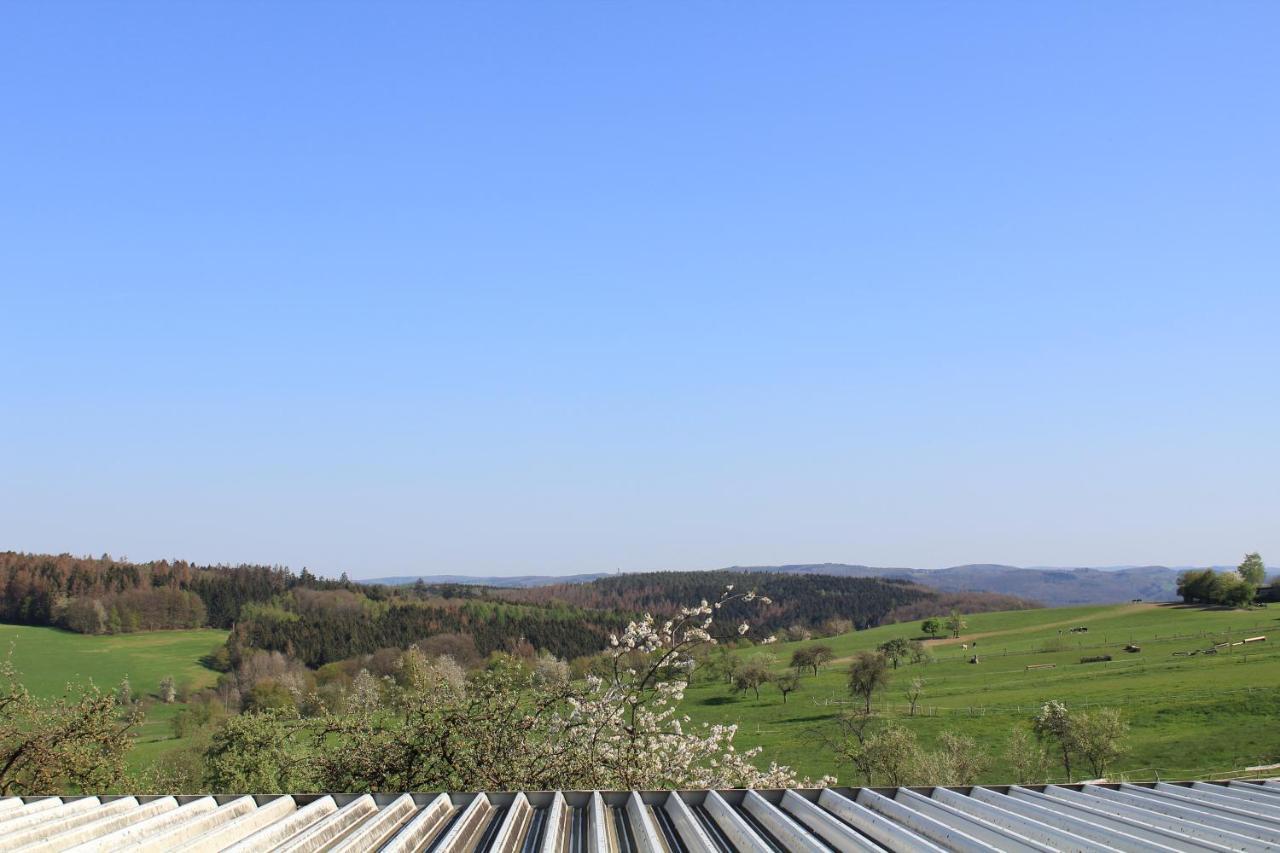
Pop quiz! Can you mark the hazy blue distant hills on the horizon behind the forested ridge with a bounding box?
[373,562,1185,607]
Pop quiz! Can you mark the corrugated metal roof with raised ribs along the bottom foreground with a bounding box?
[0,781,1280,853]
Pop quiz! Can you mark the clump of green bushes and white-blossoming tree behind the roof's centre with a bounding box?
[206,587,831,793]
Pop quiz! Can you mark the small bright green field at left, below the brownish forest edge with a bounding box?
[0,625,227,768]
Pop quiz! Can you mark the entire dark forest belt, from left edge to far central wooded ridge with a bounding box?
[0,552,1030,669]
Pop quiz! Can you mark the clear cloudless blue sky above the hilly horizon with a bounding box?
[0,1,1280,576]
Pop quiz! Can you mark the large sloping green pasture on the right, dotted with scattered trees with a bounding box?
[684,605,1280,783]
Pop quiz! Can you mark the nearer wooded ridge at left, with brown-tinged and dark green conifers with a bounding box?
[0,552,627,666]
